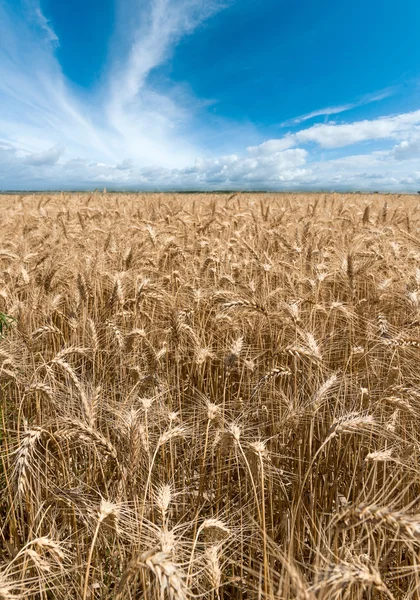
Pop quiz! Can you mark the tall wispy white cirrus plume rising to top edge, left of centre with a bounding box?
[105,0,228,166]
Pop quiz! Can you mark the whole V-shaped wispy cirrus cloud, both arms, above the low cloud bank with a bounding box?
[0,0,228,167]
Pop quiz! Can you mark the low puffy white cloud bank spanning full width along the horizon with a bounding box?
[0,137,420,192]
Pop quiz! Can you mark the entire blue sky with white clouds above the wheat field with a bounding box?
[0,0,420,192]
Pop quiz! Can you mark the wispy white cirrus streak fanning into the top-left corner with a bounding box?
[0,1,112,159]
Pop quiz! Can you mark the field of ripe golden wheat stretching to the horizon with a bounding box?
[0,192,420,600]
